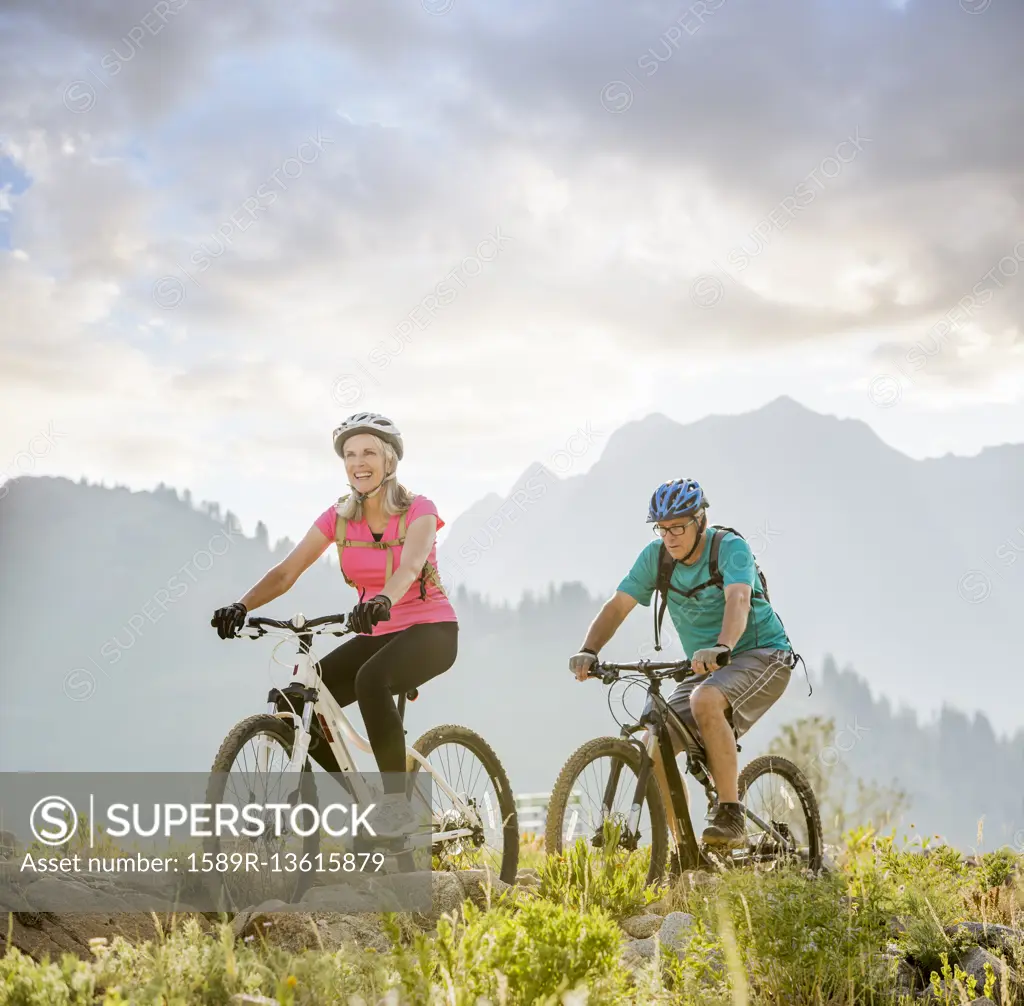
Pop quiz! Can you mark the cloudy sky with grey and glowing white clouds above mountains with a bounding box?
[0,0,1024,539]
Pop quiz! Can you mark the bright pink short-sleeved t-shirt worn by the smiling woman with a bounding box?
[314,496,458,636]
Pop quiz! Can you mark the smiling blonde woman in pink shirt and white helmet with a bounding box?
[211,412,459,823]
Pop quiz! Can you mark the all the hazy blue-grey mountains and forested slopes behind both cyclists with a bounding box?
[0,400,1024,846]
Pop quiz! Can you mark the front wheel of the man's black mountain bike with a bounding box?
[544,737,669,885]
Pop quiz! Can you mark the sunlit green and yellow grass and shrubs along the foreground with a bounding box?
[0,831,1024,1006]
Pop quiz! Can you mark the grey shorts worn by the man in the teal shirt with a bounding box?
[669,647,795,753]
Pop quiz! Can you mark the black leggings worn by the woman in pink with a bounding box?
[309,622,459,793]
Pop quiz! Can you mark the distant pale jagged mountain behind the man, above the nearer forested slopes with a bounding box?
[438,397,1024,729]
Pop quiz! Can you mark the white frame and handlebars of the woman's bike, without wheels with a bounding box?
[245,615,495,843]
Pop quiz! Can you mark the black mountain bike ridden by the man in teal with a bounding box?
[545,655,822,884]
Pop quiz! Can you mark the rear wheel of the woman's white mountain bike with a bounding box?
[407,724,519,884]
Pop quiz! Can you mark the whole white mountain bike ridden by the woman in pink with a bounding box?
[207,615,519,902]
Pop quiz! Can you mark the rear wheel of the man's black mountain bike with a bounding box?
[739,755,823,871]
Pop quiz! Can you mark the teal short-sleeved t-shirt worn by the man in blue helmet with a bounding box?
[618,528,792,657]
